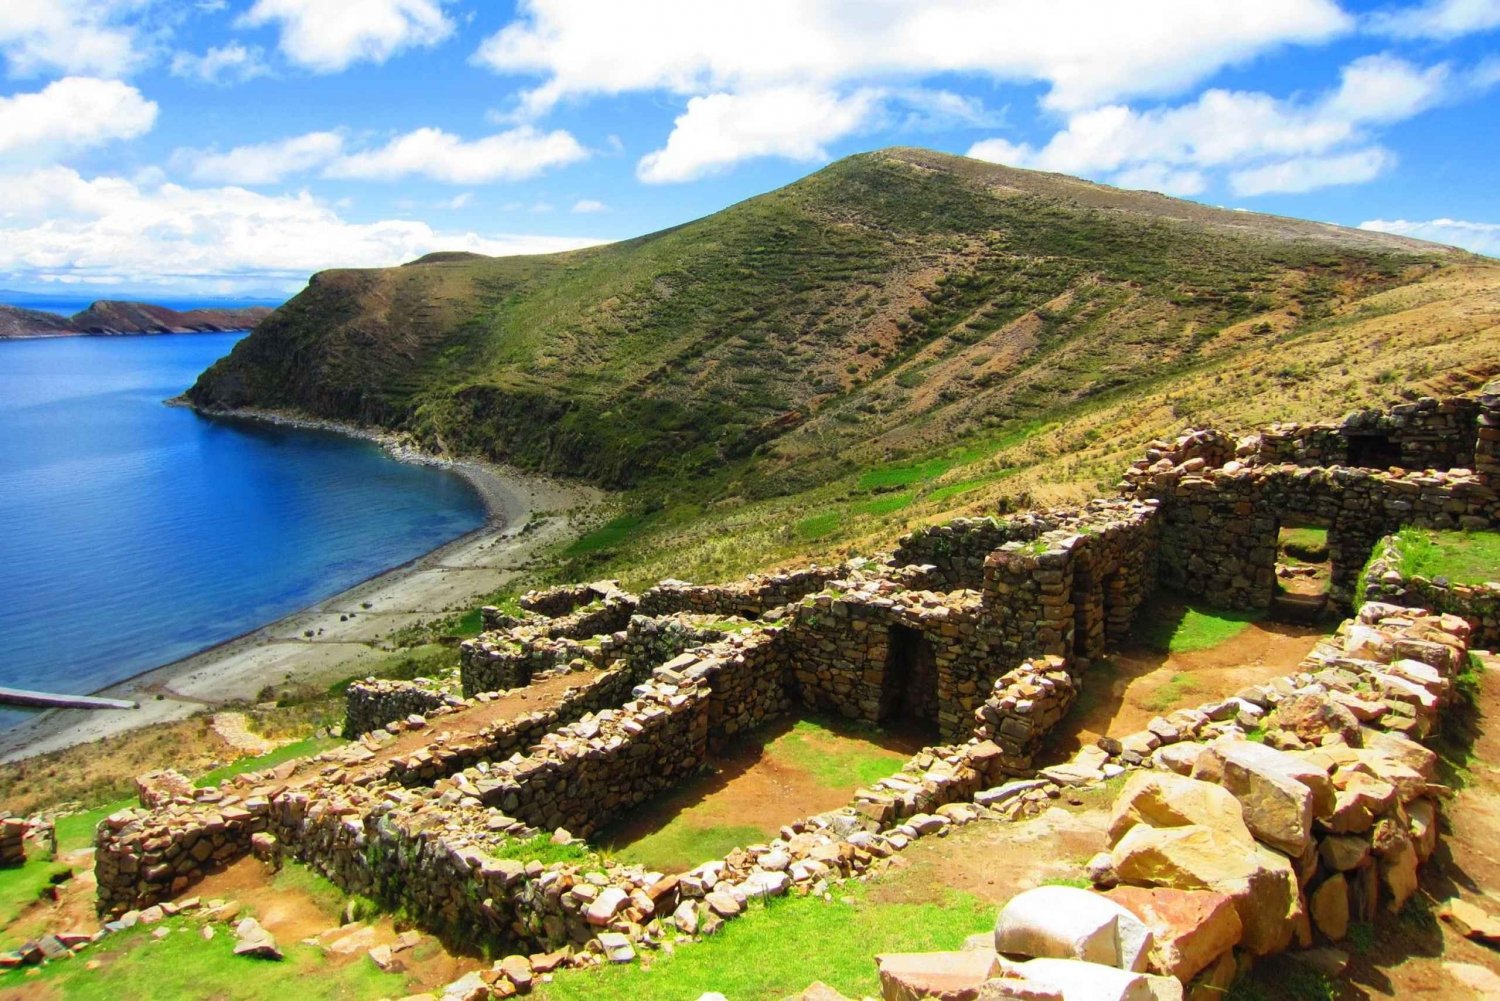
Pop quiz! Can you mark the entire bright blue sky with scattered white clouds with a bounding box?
[0,0,1500,296]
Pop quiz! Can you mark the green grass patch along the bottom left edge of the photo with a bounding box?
[11,918,408,1001]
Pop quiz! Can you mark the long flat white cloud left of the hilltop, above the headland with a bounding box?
[324,126,588,185]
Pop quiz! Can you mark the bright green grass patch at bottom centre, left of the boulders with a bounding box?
[542,882,995,1001]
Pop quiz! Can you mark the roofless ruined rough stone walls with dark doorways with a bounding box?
[96,384,1500,996]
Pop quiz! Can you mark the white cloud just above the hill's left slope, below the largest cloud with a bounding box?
[636,87,882,183]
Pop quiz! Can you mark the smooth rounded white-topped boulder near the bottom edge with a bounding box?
[995,887,1152,972]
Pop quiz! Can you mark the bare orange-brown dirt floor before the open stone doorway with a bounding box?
[1055,621,1328,755]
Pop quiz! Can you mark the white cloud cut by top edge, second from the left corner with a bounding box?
[239,0,453,74]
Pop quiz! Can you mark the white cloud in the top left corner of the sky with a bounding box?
[0,0,144,77]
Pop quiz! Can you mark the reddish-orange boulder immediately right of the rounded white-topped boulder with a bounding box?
[1109,887,1245,983]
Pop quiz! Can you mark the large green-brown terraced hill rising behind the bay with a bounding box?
[191,149,1473,492]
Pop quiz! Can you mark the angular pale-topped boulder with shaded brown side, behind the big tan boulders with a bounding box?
[1214,740,1328,858]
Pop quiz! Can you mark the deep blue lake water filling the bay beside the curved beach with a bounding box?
[0,333,485,726]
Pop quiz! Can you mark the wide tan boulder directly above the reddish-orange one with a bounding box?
[1110,824,1302,956]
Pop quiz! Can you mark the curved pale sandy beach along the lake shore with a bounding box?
[0,413,603,761]
